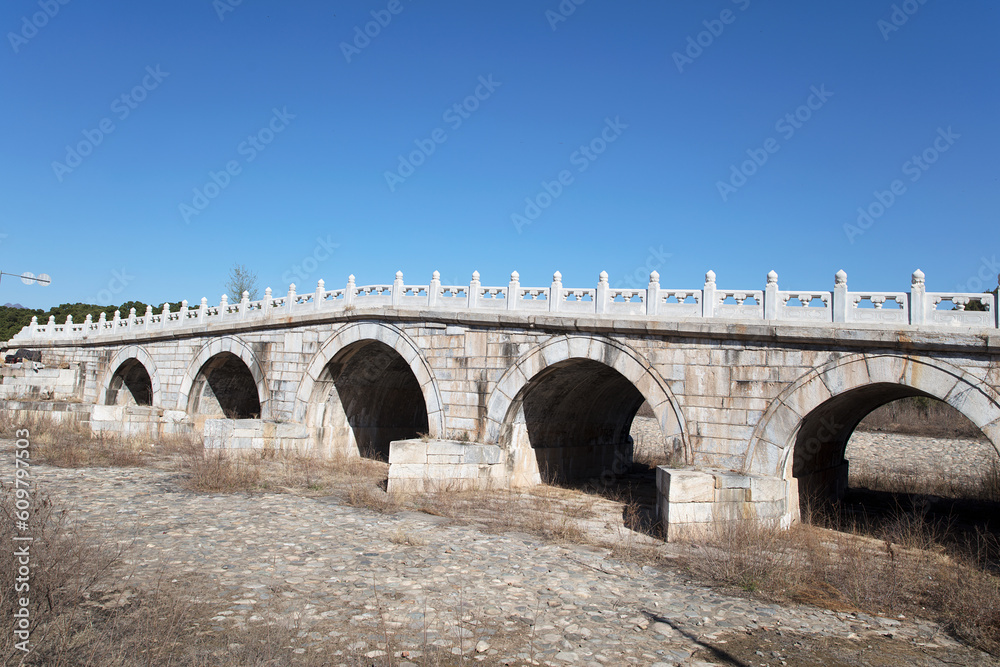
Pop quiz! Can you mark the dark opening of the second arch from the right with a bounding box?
[505,358,666,505]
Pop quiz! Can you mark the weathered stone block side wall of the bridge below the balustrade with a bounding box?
[4,307,1000,506]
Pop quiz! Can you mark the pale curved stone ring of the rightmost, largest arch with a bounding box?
[743,354,1000,500]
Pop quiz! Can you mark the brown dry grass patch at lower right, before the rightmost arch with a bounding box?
[692,517,1000,655]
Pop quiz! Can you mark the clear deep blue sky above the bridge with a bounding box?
[0,0,1000,307]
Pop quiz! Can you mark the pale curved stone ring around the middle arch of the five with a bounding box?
[293,321,445,448]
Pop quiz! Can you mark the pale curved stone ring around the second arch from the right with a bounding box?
[482,335,690,484]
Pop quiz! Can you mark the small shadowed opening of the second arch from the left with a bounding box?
[188,352,261,419]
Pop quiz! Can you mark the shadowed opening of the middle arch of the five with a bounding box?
[311,340,429,461]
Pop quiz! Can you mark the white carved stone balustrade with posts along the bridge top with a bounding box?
[11,270,998,343]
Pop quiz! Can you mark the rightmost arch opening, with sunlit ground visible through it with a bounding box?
[790,383,1000,562]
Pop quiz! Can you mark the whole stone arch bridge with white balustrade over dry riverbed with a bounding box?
[0,271,1000,538]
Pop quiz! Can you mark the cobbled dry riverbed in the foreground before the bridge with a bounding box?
[0,430,994,666]
